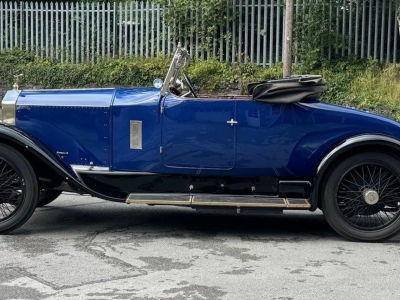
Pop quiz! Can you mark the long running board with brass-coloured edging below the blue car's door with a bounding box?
[125,194,311,209]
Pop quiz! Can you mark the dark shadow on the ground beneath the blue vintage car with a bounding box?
[12,201,360,240]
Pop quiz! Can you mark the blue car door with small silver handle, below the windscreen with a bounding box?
[160,94,236,169]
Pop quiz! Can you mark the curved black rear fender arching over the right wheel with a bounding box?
[310,134,400,211]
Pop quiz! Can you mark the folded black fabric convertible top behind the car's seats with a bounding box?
[247,75,326,103]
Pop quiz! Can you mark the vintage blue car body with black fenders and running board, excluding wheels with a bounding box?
[0,44,400,241]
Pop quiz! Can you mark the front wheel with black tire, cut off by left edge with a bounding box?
[0,145,39,233]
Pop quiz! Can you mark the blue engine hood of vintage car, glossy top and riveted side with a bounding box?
[7,88,160,167]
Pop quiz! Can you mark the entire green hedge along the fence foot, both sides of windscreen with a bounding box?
[0,50,400,120]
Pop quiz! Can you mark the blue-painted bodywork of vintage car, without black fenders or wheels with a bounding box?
[10,88,400,180]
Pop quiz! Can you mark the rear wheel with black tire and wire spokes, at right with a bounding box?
[322,152,400,242]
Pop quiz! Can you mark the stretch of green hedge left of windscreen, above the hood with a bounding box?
[0,50,169,89]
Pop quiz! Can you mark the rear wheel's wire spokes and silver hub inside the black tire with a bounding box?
[337,164,400,230]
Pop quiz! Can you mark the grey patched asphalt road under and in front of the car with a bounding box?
[0,195,400,300]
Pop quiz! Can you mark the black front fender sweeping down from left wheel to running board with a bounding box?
[0,123,121,202]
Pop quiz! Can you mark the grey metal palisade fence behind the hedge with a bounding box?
[0,0,400,66]
